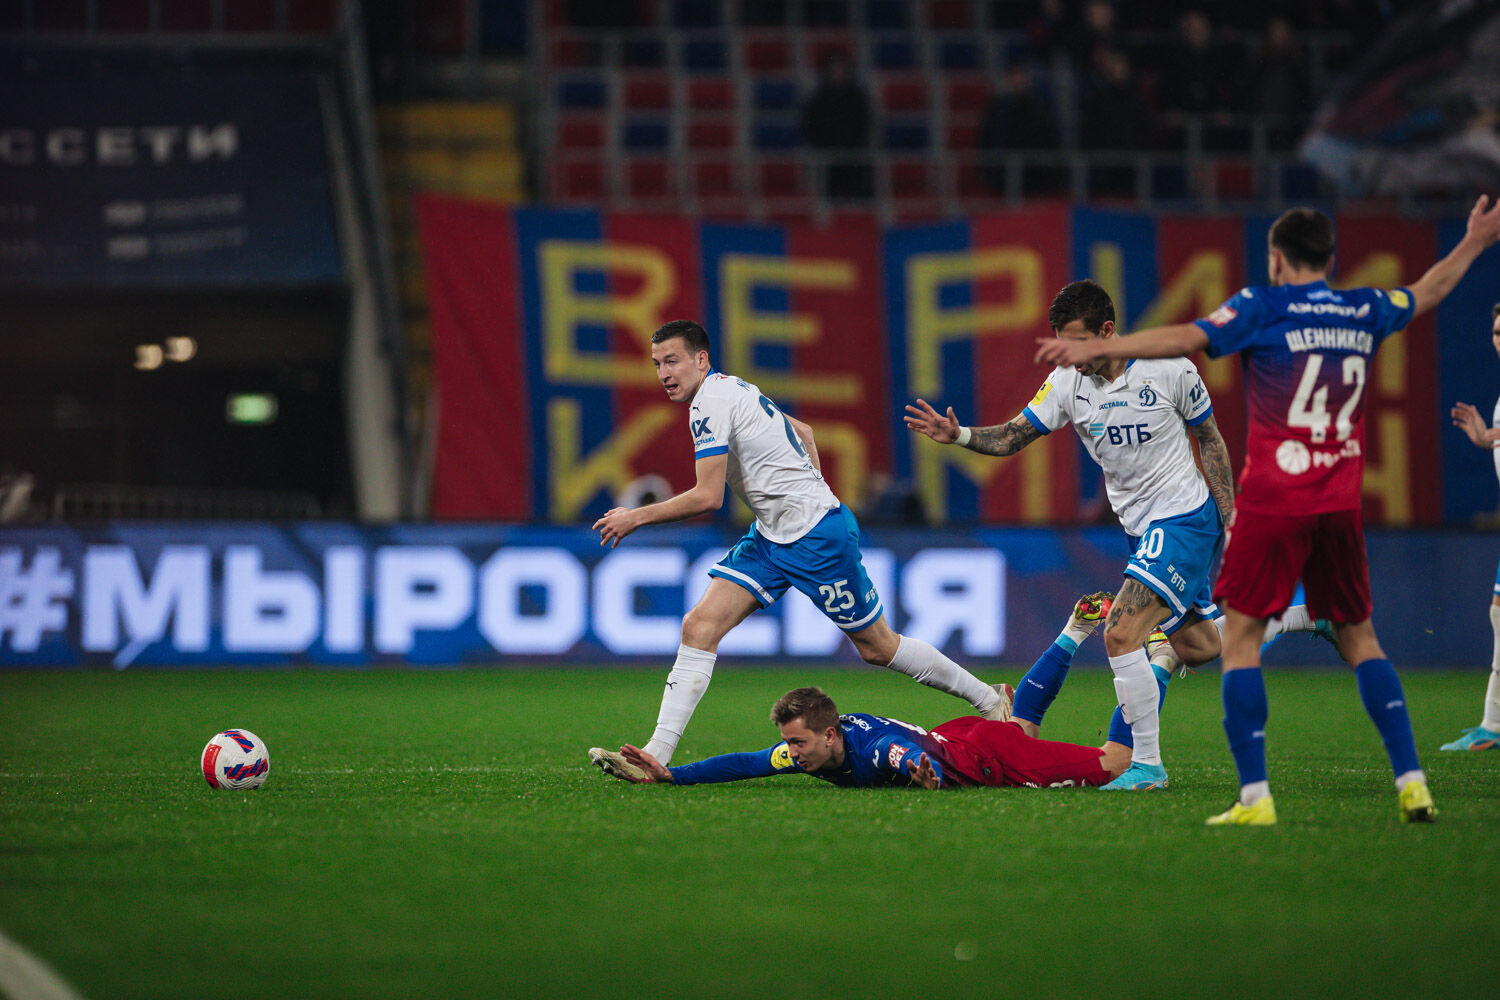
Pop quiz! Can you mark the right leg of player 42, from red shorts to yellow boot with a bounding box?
[1304,510,1437,822]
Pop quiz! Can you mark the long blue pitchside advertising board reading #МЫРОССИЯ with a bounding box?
[0,523,1500,670]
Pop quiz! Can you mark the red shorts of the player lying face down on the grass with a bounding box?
[932,715,1110,789]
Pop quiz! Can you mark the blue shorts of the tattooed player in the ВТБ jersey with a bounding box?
[1125,496,1224,636]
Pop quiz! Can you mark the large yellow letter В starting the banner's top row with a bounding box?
[537,240,677,385]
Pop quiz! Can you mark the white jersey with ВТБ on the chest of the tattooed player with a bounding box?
[1022,358,1214,537]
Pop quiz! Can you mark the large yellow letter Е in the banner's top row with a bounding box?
[719,253,873,403]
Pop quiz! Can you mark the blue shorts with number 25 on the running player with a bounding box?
[708,504,881,633]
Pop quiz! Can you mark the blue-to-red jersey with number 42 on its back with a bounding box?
[1197,282,1413,514]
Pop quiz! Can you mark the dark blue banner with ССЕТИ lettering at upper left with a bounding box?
[0,55,342,289]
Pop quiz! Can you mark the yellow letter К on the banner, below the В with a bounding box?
[548,399,672,522]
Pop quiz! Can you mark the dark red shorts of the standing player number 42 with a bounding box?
[1214,510,1374,625]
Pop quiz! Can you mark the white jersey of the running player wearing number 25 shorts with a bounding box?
[687,372,839,544]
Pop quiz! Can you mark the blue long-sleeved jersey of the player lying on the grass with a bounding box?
[668,714,948,789]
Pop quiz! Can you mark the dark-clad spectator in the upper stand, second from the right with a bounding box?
[1160,10,1244,148]
